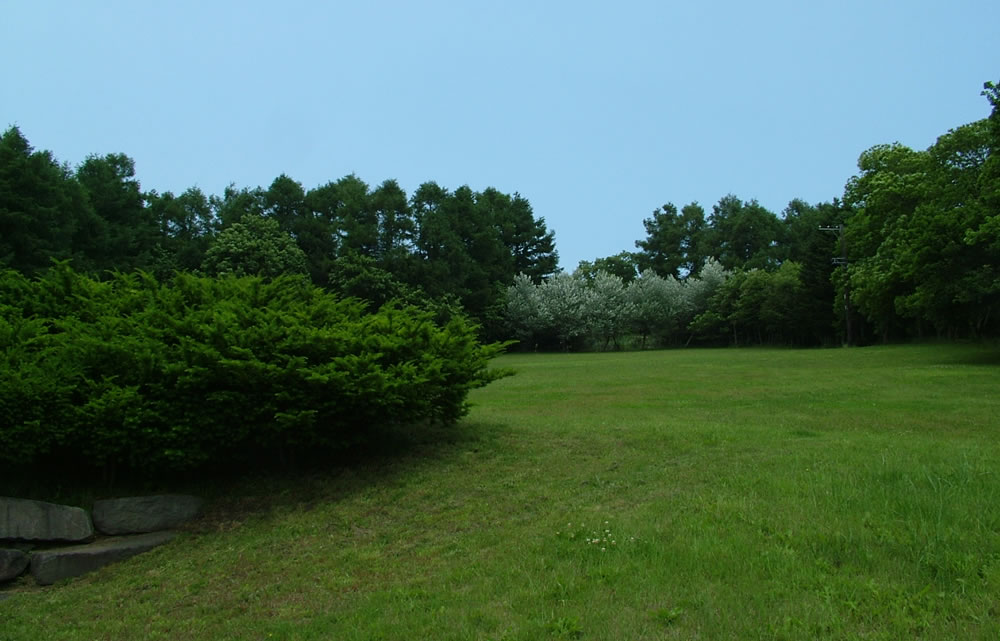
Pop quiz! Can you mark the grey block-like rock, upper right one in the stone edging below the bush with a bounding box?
[94,494,201,535]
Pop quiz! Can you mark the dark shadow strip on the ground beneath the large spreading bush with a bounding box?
[0,419,509,533]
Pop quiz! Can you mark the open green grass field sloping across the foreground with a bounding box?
[0,345,1000,641]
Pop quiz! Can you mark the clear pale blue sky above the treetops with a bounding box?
[0,0,1000,269]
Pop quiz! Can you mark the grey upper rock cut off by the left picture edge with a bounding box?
[0,497,94,542]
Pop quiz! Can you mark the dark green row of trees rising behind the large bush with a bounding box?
[0,127,558,334]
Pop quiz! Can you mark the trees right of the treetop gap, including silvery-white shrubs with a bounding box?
[536,83,1000,349]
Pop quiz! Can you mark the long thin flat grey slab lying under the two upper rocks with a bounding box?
[31,532,176,585]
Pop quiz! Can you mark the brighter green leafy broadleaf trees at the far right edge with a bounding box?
[845,99,1000,341]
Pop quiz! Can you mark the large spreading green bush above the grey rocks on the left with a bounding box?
[0,265,502,471]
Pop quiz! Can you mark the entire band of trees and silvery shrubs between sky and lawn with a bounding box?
[0,83,1000,349]
